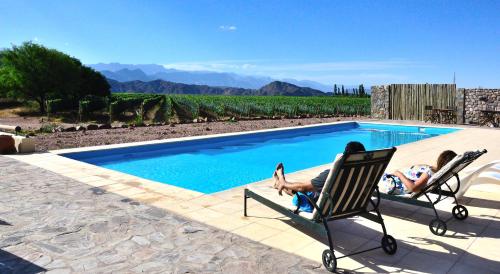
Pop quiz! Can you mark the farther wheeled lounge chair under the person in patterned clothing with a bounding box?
[376,150,487,236]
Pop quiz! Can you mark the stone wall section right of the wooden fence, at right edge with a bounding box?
[464,89,500,124]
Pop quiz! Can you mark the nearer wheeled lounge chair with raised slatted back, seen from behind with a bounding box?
[244,148,397,272]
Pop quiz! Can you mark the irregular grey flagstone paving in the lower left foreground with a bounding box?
[0,156,325,273]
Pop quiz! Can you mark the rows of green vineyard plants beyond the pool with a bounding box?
[110,93,370,119]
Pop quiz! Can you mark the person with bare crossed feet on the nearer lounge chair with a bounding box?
[273,142,366,201]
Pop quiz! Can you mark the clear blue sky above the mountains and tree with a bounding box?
[0,0,500,87]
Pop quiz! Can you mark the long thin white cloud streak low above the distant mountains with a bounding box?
[164,60,422,84]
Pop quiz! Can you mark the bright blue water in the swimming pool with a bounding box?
[64,122,458,193]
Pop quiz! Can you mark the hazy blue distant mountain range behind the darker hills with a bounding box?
[89,63,332,92]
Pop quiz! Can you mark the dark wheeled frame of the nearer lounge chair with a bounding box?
[243,147,397,272]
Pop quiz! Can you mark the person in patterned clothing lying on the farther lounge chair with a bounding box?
[379,150,457,195]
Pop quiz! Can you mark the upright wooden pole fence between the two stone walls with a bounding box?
[389,84,457,121]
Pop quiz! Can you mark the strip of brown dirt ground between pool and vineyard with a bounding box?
[0,114,367,151]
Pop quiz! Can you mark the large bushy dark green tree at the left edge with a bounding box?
[0,42,110,114]
